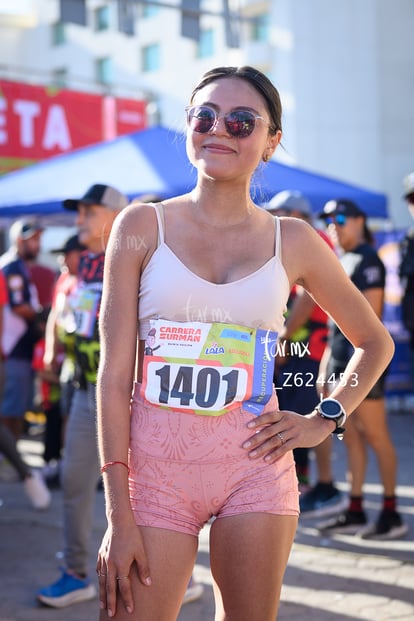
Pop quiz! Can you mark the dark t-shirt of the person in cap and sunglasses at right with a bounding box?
[329,244,385,366]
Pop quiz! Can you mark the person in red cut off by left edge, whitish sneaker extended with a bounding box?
[0,270,51,509]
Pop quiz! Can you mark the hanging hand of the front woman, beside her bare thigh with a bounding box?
[96,520,151,617]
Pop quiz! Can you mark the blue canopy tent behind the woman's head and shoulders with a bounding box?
[0,127,387,223]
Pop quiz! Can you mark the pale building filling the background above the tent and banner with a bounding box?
[0,0,414,228]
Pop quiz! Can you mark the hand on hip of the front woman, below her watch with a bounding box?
[243,410,333,463]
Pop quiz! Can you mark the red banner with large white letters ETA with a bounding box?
[0,80,147,173]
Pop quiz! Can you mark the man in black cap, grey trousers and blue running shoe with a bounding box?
[37,184,128,608]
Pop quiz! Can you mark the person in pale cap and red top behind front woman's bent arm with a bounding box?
[265,190,343,508]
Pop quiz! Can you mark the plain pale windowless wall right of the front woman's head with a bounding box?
[272,0,414,227]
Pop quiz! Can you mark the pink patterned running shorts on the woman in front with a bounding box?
[129,384,299,536]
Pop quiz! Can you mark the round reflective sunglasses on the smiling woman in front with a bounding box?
[185,106,266,138]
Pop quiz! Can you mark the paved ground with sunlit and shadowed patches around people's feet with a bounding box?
[0,404,414,621]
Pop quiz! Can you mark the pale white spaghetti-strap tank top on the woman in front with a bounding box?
[138,203,290,340]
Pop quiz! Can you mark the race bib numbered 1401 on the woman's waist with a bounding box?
[142,319,277,416]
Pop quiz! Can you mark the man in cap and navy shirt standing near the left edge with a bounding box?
[0,219,43,440]
